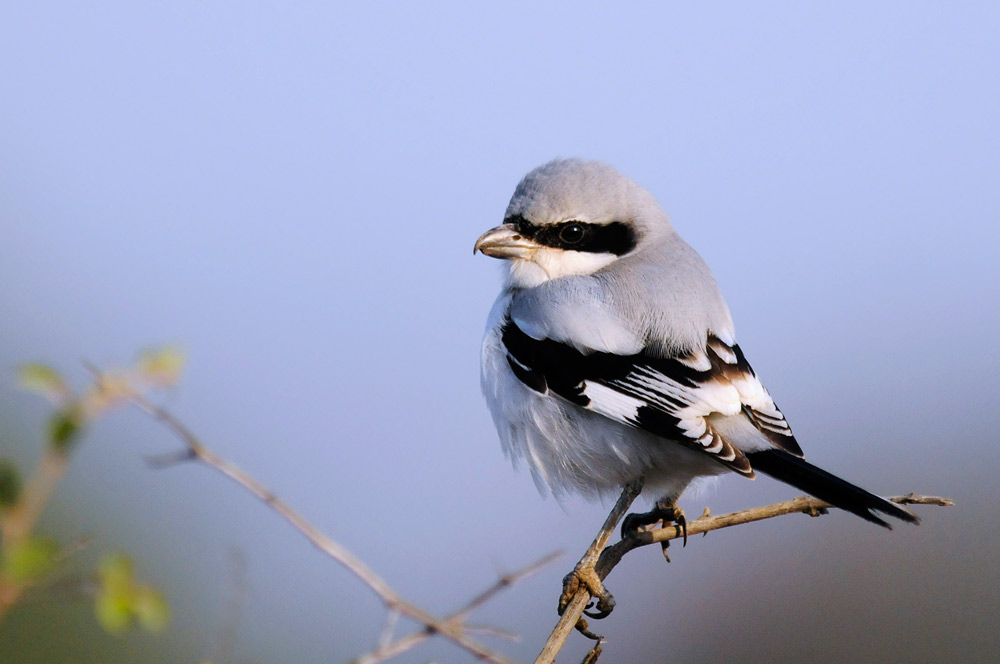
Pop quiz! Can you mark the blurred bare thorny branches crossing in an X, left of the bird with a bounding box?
[123,390,556,664]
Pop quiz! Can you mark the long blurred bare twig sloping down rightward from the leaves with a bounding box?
[126,393,524,664]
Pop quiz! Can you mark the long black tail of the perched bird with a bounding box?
[747,450,920,530]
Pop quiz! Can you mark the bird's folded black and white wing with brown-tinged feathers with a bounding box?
[502,318,802,477]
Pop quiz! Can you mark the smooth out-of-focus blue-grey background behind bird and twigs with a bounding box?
[0,1,1000,664]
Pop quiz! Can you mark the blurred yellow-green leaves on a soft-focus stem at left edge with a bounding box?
[0,348,184,634]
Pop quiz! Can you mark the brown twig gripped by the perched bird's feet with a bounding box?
[535,493,955,664]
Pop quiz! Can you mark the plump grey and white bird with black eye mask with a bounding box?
[473,159,918,560]
